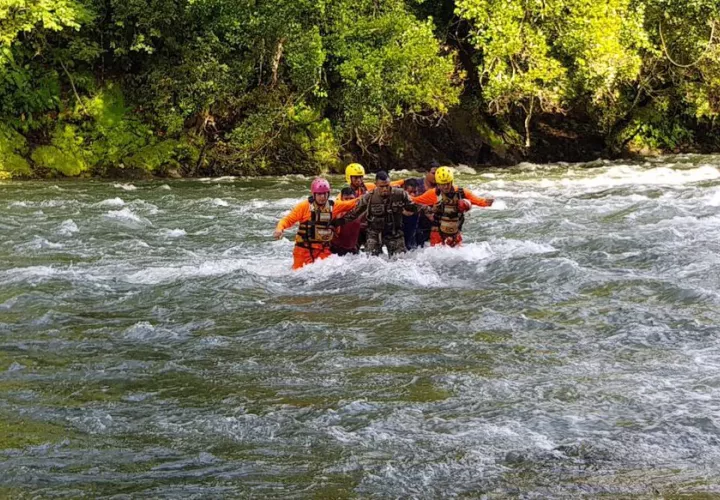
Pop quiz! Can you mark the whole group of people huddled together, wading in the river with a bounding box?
[274,163,494,269]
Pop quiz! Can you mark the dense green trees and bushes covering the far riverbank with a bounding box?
[0,0,720,177]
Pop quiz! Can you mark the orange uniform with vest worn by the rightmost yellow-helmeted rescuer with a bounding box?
[412,187,493,247]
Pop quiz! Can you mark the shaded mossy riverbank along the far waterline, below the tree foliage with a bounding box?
[0,111,720,180]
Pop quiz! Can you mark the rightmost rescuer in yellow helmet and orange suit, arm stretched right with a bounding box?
[412,167,495,247]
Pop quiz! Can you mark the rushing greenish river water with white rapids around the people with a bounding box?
[0,156,720,498]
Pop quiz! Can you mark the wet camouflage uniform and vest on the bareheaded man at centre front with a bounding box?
[344,187,417,255]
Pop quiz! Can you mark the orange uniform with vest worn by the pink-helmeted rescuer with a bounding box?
[276,196,358,269]
